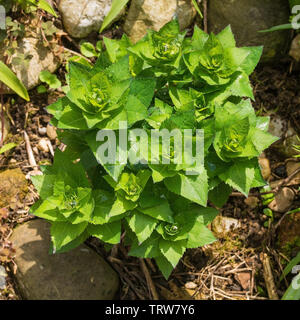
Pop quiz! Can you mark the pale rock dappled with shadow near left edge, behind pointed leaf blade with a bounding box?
[0,38,60,93]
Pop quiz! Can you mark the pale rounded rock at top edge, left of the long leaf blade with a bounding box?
[58,0,123,38]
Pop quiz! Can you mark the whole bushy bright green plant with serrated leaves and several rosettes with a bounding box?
[31,20,276,278]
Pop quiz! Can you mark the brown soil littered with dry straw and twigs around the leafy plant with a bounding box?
[0,11,300,300]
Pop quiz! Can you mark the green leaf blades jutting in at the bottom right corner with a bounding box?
[280,252,300,300]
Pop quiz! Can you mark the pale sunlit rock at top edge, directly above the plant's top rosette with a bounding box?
[124,0,196,42]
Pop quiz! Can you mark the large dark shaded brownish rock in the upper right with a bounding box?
[208,0,292,61]
